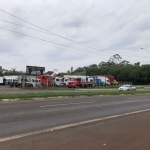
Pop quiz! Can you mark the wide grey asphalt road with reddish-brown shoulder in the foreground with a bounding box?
[0,94,150,150]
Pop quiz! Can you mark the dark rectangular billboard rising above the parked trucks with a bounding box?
[26,66,45,75]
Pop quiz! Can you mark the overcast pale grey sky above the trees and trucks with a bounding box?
[0,0,150,72]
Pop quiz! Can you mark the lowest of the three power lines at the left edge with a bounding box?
[0,27,149,62]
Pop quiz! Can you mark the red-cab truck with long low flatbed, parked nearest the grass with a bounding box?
[67,78,96,88]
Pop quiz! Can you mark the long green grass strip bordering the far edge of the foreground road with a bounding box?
[0,91,150,100]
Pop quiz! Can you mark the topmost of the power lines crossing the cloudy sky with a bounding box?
[0,9,144,57]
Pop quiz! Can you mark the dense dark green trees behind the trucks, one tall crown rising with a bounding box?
[70,54,150,84]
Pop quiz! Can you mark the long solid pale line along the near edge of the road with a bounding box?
[0,109,150,143]
